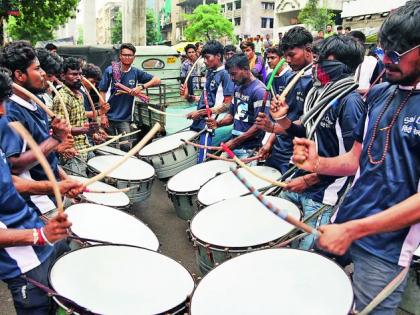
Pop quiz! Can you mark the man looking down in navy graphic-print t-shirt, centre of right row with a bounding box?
[207,53,268,158]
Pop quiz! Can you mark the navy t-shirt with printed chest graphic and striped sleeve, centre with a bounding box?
[229,79,269,149]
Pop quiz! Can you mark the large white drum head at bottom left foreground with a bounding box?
[50,245,194,314]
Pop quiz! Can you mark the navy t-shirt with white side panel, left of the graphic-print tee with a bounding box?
[191,66,235,131]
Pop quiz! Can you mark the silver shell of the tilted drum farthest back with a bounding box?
[139,144,198,179]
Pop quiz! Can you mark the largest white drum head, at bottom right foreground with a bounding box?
[191,249,353,315]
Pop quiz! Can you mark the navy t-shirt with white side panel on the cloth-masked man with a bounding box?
[297,91,366,205]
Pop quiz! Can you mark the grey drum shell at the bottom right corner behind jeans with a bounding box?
[400,256,420,315]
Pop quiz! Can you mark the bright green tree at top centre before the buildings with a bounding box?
[185,4,234,41]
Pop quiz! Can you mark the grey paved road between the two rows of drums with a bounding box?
[0,180,414,315]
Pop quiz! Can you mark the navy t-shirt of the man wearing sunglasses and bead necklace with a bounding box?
[335,83,420,266]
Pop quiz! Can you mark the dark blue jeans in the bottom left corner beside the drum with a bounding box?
[4,241,69,315]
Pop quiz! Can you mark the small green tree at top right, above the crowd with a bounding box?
[298,0,335,31]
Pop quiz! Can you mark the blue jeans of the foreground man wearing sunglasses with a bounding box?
[350,245,408,315]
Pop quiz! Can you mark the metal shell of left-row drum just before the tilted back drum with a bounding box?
[87,165,155,203]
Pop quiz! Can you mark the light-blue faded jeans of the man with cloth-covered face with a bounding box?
[279,191,333,250]
